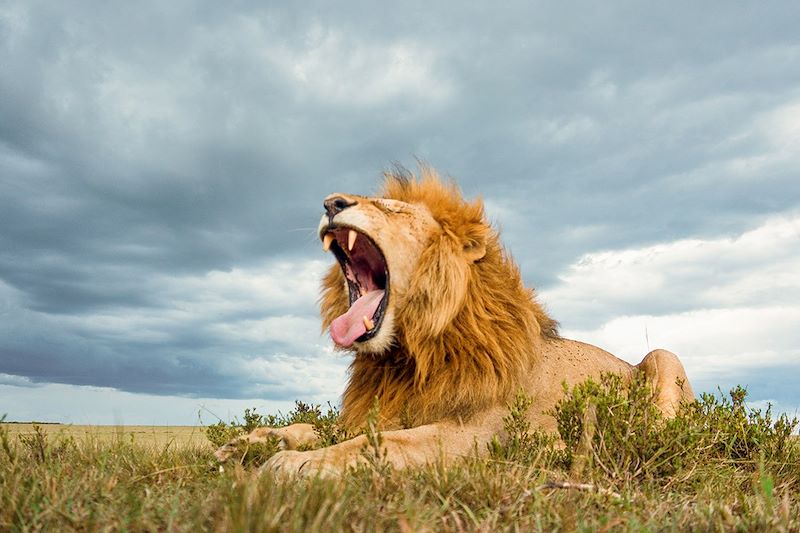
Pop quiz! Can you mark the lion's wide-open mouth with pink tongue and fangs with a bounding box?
[323,228,389,347]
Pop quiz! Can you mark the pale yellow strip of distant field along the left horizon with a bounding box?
[2,424,211,448]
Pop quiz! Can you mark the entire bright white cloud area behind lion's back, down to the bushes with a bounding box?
[541,215,800,411]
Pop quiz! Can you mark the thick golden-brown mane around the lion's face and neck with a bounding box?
[320,168,558,429]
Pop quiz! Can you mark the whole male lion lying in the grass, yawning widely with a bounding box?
[215,167,694,475]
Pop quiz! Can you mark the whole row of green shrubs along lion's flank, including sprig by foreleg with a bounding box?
[482,374,800,486]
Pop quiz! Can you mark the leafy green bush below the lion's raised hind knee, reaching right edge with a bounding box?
[552,374,800,479]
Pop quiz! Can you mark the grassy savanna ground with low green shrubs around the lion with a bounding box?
[0,376,800,532]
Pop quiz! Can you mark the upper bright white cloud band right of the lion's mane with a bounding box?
[542,213,800,327]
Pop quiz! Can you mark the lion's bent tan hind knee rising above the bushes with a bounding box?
[636,350,694,418]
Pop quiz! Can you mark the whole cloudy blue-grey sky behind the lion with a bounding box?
[0,0,800,424]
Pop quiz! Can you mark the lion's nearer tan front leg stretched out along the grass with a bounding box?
[261,422,497,476]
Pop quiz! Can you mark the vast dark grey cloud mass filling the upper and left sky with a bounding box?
[0,2,800,404]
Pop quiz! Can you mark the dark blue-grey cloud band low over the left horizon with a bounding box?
[0,306,332,399]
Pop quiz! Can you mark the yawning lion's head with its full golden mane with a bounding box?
[319,168,557,426]
